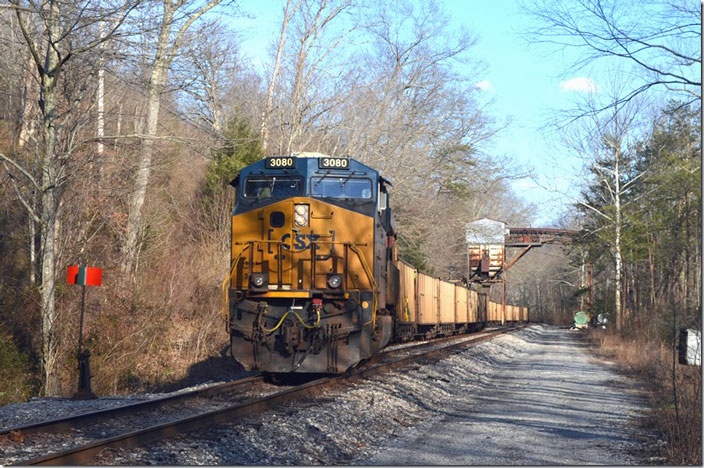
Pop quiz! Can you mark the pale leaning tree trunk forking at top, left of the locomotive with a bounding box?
[122,0,222,275]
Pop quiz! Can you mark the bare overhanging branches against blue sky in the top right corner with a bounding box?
[526,0,701,116]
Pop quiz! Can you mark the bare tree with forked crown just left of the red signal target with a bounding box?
[0,0,137,395]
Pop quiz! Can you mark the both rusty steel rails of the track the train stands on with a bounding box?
[5,327,521,465]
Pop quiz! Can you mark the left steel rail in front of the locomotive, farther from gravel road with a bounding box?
[0,374,263,437]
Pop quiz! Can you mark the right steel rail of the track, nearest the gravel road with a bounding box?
[12,327,518,465]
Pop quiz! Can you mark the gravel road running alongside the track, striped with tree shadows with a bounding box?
[364,327,652,465]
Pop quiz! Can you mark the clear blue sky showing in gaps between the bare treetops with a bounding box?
[233,0,598,227]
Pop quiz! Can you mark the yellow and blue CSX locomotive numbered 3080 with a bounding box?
[223,153,399,373]
